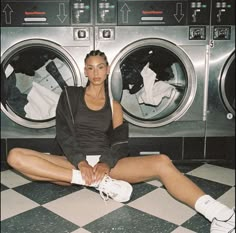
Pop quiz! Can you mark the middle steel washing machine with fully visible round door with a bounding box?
[95,0,210,157]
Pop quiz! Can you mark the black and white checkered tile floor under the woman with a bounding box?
[1,163,235,233]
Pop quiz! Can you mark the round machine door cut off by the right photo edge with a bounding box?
[220,53,235,119]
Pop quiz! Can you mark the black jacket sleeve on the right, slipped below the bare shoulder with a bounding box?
[100,122,129,168]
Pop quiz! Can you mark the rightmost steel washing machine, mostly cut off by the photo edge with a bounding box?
[206,0,235,158]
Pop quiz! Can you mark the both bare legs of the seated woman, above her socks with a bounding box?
[7,148,204,207]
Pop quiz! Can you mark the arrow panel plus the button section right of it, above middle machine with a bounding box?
[114,0,211,26]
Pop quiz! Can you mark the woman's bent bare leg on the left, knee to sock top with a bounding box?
[7,148,75,185]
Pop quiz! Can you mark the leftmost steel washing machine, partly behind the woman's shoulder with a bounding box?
[1,0,94,139]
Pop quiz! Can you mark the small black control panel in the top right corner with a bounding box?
[211,0,235,25]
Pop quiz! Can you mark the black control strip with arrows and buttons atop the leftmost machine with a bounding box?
[1,0,93,27]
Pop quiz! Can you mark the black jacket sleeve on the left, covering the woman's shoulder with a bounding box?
[56,89,86,168]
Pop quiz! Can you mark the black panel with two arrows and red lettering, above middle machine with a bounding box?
[118,0,187,26]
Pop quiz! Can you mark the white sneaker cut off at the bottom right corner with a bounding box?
[211,212,235,233]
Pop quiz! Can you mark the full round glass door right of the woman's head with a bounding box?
[110,39,197,127]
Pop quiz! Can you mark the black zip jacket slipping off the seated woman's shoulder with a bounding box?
[56,86,128,168]
